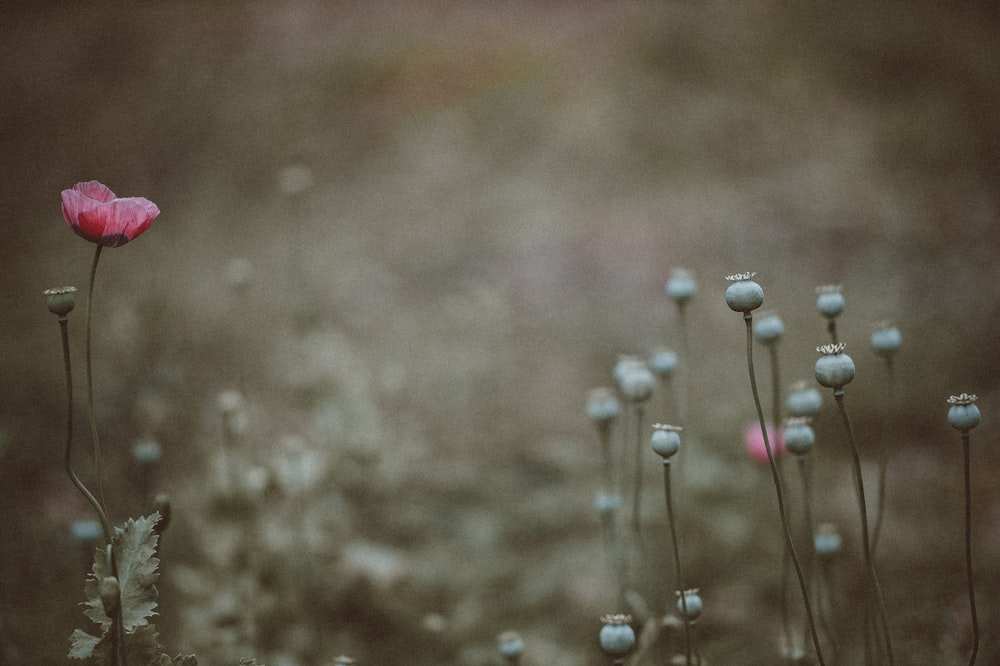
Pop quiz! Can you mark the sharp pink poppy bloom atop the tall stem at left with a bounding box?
[62,180,160,247]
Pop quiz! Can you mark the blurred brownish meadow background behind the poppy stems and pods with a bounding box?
[0,1,1000,666]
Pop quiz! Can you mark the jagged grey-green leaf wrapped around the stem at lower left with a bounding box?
[84,512,160,632]
